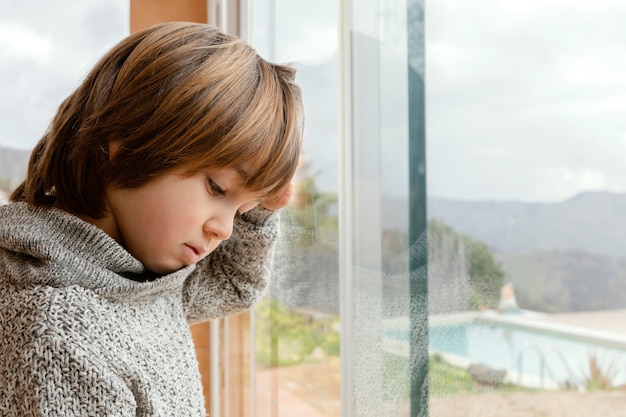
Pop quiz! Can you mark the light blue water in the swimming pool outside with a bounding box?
[389,320,626,386]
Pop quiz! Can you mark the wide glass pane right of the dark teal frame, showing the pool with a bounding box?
[426,0,626,417]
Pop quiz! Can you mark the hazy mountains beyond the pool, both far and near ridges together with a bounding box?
[427,191,626,313]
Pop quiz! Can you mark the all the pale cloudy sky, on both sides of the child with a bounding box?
[0,0,626,202]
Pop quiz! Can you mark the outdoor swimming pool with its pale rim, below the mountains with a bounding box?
[386,315,626,388]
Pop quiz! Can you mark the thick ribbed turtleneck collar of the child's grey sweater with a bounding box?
[0,202,195,299]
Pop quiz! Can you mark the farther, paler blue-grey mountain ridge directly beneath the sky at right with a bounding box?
[427,191,626,258]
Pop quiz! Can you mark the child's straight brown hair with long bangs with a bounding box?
[11,22,302,218]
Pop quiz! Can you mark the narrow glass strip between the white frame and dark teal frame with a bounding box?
[346,1,416,416]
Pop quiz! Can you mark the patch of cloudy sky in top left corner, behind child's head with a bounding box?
[0,0,130,149]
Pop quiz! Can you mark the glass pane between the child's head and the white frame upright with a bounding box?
[251,0,341,417]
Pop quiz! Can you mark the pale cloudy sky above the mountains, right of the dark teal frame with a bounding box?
[426,0,626,201]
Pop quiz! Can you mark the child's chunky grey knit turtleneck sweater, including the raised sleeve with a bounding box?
[0,203,278,417]
